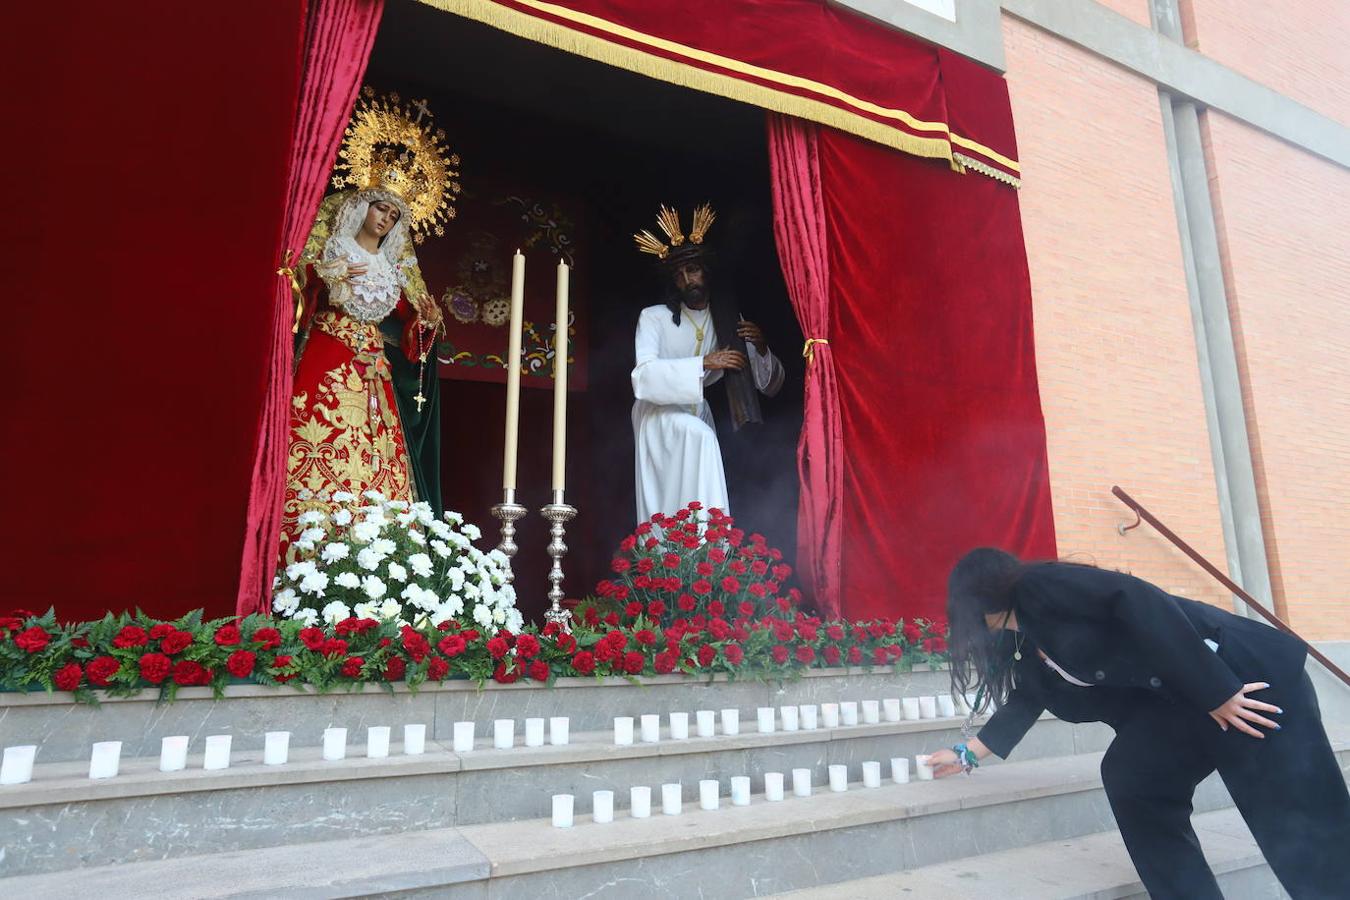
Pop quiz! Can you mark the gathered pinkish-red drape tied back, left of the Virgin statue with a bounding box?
[236,0,385,615]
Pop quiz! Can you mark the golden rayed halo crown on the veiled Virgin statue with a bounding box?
[332,85,463,243]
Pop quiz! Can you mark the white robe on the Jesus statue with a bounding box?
[633,301,783,522]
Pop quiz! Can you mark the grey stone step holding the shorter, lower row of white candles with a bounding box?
[0,741,1350,900]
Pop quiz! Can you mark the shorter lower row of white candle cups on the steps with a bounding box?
[552,754,933,828]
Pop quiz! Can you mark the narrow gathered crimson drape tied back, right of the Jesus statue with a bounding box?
[768,113,844,617]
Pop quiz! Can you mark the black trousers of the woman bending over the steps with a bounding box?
[1102,673,1350,900]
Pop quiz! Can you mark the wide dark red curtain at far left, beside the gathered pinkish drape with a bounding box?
[0,0,305,619]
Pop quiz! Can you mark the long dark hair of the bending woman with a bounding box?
[946,546,1023,712]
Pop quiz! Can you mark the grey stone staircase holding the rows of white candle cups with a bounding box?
[0,658,1350,900]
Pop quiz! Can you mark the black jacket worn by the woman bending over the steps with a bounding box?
[980,563,1307,757]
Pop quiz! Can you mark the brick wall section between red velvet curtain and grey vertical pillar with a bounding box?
[1003,16,1229,604]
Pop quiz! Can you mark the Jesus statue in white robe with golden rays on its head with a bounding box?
[632,205,783,522]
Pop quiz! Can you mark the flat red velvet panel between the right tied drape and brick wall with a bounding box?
[819,130,1054,618]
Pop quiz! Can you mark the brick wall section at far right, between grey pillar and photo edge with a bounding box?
[1204,112,1350,640]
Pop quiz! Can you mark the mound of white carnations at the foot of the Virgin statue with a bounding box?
[273,491,522,631]
